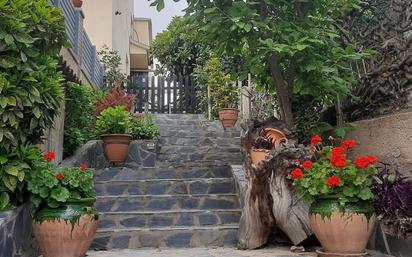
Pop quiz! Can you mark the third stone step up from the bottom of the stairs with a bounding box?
[96,194,240,212]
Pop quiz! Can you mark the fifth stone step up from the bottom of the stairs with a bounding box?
[93,163,232,182]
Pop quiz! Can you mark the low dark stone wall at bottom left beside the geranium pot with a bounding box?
[0,204,38,257]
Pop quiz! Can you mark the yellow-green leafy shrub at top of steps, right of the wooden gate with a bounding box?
[194,57,239,117]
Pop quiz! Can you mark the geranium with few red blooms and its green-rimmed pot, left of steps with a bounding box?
[27,150,97,257]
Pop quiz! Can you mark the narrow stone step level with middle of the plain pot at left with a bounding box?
[159,145,240,155]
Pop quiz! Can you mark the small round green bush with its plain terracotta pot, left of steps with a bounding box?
[96,106,132,163]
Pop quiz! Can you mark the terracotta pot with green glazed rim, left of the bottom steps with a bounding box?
[33,199,97,257]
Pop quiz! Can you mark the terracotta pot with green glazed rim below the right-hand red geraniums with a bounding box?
[310,197,375,254]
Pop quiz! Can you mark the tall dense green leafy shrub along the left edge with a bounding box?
[0,0,66,207]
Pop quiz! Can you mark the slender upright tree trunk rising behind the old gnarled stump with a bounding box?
[269,54,293,128]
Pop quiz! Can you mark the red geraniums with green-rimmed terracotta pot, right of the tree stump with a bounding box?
[289,135,377,257]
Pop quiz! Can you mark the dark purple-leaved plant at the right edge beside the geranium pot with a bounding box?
[372,163,412,256]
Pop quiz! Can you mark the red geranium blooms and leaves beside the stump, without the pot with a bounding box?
[289,135,377,211]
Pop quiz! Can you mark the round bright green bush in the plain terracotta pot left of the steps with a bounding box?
[96,106,130,135]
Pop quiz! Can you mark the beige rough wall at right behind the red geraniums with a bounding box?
[347,111,412,178]
